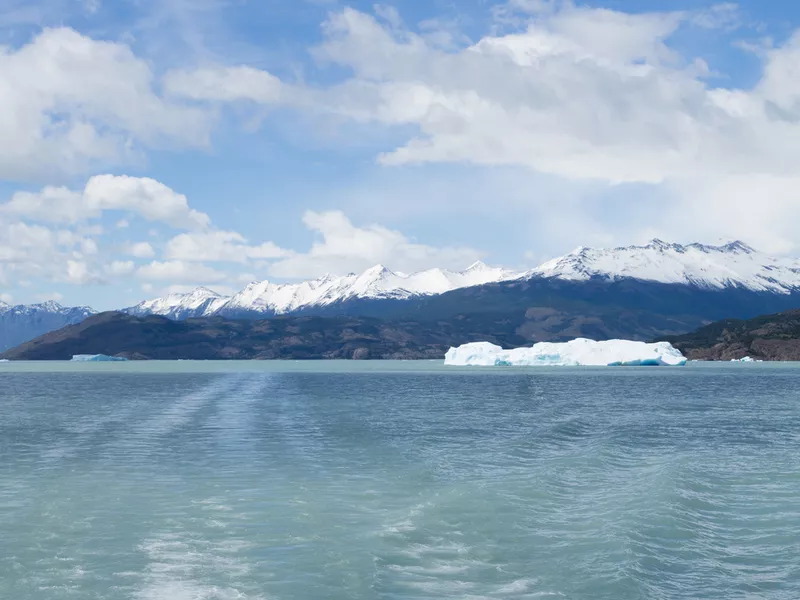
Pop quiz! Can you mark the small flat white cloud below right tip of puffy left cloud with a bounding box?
[164,231,288,263]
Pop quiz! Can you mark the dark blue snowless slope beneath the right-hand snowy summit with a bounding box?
[383,278,800,341]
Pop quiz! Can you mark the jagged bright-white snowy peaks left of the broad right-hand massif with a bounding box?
[125,262,521,319]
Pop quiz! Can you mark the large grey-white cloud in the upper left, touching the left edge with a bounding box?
[0,27,211,180]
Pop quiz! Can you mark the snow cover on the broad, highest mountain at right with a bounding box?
[526,239,800,294]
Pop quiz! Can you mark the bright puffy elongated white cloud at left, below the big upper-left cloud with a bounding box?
[0,175,211,229]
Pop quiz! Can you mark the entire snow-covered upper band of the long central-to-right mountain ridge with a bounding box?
[124,239,800,319]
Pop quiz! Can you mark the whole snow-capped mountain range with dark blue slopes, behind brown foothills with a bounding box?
[0,240,800,356]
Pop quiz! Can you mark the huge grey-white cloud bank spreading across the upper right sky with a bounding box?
[161,0,800,251]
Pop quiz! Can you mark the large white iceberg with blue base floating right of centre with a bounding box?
[444,338,686,367]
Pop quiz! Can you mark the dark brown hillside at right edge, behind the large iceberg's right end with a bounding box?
[666,310,800,361]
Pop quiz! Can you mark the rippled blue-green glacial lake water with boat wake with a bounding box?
[0,362,800,600]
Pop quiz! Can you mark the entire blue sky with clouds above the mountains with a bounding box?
[0,0,800,310]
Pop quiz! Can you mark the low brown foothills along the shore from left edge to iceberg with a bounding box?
[0,312,524,360]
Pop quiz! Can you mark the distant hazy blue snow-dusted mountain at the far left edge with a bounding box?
[0,301,95,351]
